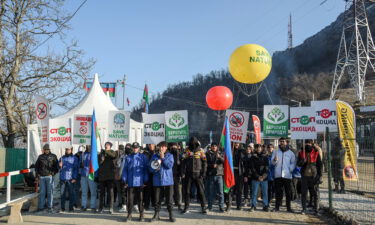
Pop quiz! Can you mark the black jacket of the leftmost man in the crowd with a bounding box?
[35,153,59,176]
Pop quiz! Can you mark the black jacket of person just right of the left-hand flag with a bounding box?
[98,150,117,182]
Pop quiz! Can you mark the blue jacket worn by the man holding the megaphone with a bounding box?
[150,152,174,186]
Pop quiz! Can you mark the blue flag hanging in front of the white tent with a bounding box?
[89,109,100,180]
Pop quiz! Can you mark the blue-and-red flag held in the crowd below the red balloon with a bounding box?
[220,117,236,193]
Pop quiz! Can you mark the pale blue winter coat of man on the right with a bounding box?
[271,149,296,179]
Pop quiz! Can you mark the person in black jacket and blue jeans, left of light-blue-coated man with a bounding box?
[250,144,269,212]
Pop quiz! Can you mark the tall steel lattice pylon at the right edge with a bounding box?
[330,0,375,103]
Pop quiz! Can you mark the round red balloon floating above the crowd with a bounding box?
[206,86,233,110]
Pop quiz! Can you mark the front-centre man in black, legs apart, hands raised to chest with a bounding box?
[181,137,207,214]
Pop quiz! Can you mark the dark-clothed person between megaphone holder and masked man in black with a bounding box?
[168,142,182,211]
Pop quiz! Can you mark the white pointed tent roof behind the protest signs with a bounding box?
[56,74,118,127]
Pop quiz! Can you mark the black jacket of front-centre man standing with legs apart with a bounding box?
[181,148,207,177]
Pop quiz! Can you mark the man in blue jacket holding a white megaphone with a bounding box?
[150,141,176,222]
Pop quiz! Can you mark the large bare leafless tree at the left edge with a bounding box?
[0,0,94,147]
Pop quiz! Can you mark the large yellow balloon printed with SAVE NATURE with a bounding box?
[229,44,272,84]
